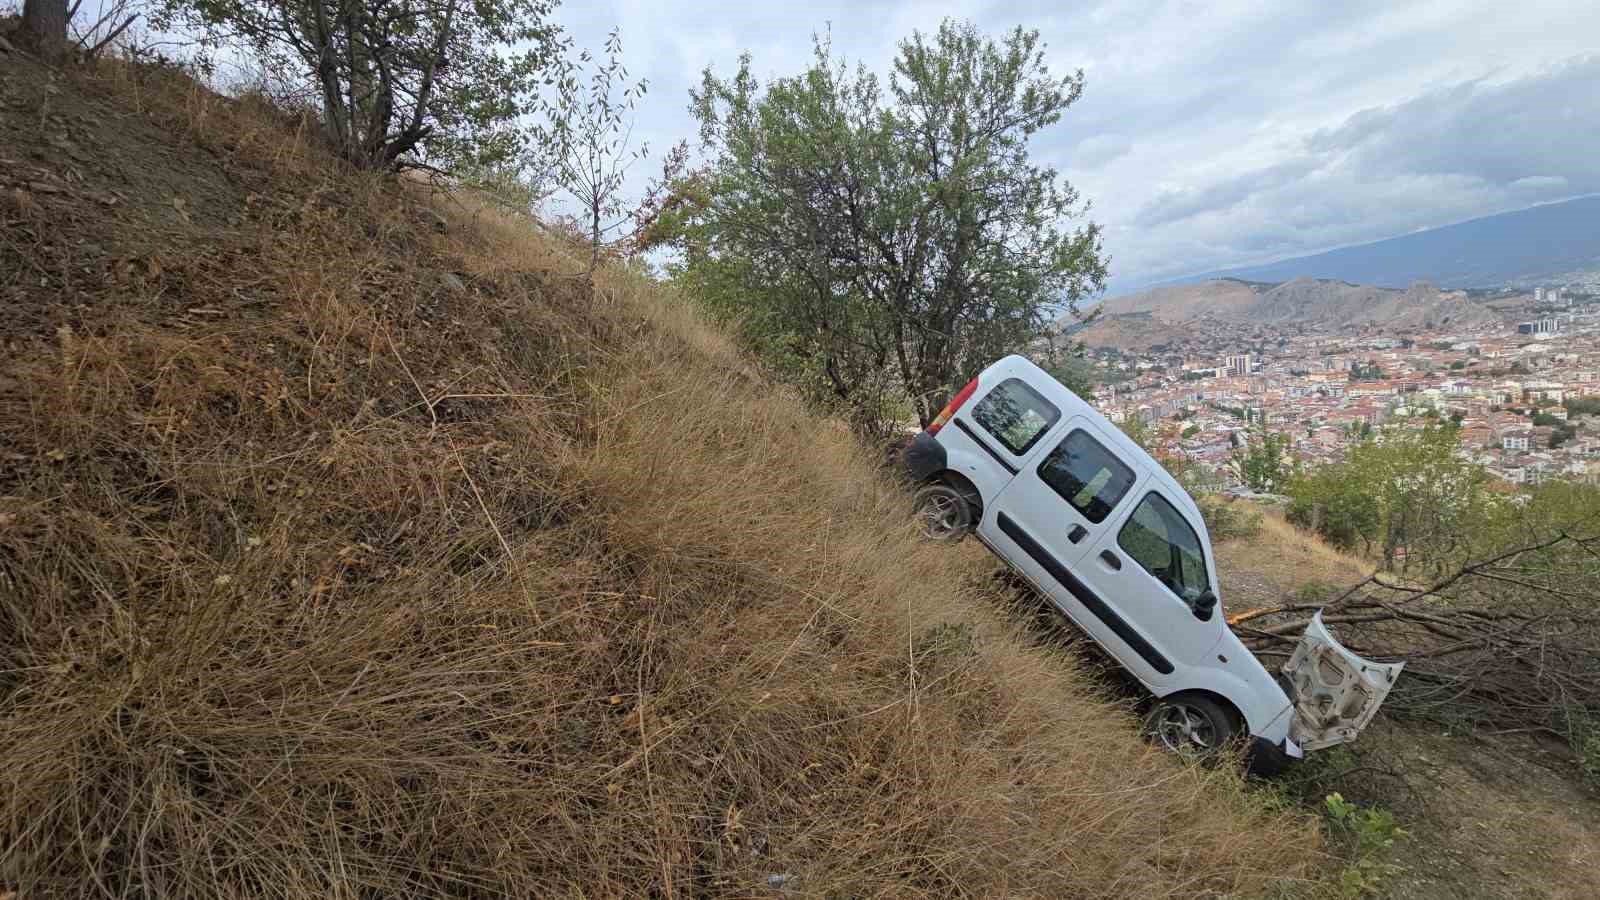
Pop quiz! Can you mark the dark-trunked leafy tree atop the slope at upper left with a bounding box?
[157,0,562,168]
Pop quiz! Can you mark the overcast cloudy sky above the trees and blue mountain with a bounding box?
[557,0,1600,293]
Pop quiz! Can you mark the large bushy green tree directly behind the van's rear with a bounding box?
[658,21,1106,429]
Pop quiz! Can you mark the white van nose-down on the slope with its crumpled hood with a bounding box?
[901,356,1403,770]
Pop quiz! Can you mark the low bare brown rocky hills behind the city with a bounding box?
[1077,279,1499,351]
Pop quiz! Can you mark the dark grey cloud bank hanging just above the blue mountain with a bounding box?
[1115,56,1600,290]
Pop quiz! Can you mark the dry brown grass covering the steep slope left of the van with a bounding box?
[0,52,1320,897]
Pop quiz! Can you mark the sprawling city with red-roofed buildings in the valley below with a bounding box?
[1091,285,1600,485]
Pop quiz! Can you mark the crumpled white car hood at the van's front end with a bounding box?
[1283,612,1405,749]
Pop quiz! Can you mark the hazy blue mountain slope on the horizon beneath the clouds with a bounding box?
[1163,197,1600,288]
